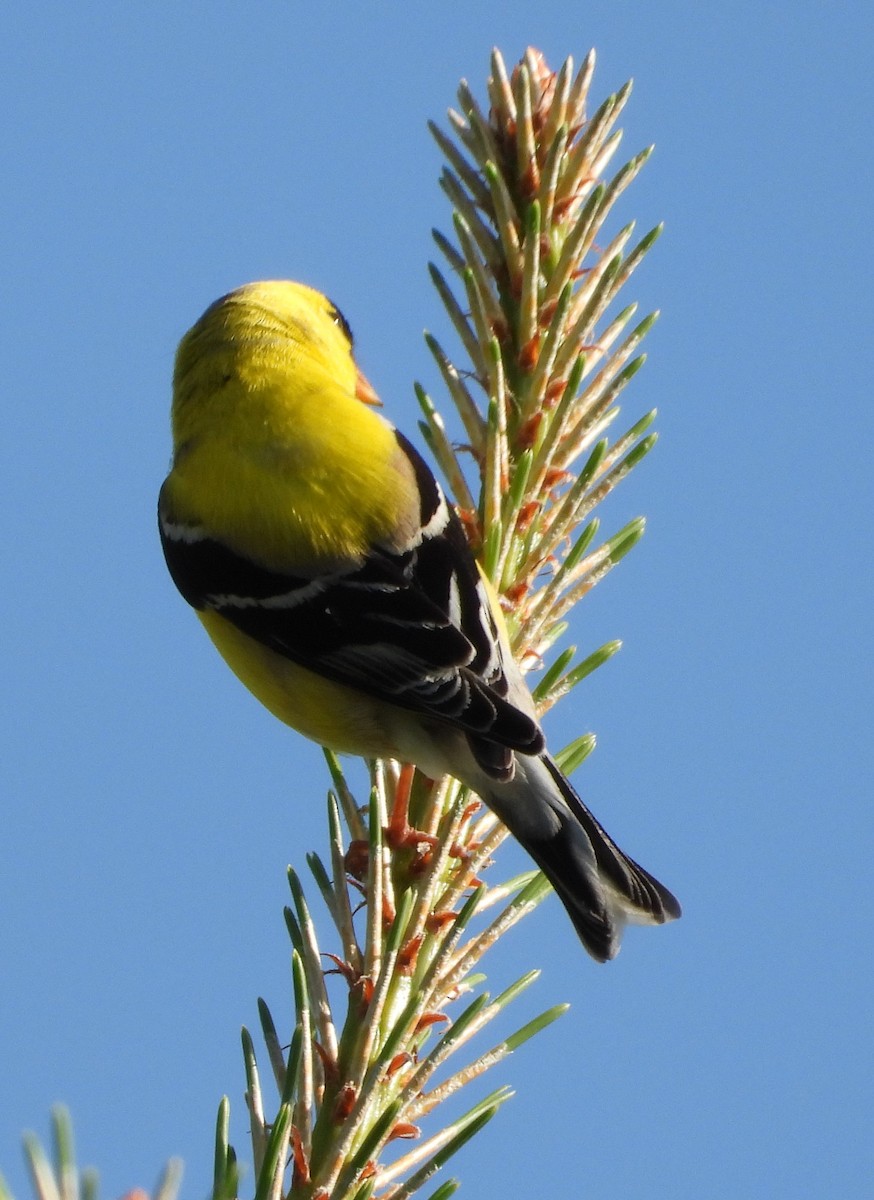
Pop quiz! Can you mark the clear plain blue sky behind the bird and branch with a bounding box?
[0,0,874,1200]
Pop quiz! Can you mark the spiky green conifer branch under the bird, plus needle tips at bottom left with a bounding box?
[6,42,659,1200]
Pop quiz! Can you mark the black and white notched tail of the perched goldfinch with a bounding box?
[487,755,681,962]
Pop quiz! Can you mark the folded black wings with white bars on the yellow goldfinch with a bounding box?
[161,433,543,778]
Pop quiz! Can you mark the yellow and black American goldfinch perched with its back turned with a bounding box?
[158,282,680,961]
